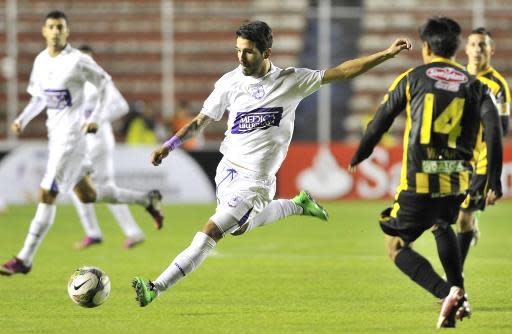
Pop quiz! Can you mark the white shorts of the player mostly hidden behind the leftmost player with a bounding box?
[86,122,115,184]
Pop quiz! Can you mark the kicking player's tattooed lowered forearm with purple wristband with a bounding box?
[151,114,213,166]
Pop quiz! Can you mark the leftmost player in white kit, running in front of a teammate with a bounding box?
[0,11,163,276]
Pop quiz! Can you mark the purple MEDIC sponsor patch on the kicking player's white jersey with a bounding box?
[231,107,283,134]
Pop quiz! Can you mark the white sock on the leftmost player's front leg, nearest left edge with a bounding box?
[17,203,57,266]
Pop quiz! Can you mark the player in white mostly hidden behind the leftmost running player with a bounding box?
[70,45,144,249]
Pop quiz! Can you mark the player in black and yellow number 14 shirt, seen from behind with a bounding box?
[349,17,502,327]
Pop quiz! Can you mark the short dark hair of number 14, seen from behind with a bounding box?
[419,16,461,58]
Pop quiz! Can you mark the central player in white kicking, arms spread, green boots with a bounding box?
[132,21,411,306]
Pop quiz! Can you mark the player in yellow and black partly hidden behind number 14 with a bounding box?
[457,27,510,269]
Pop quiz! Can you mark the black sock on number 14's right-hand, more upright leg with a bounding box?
[432,226,464,288]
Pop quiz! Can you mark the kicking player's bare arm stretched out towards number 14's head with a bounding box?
[322,38,412,84]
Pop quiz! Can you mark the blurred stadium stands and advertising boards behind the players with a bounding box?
[0,0,512,202]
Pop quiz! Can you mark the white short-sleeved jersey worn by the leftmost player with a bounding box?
[27,44,110,140]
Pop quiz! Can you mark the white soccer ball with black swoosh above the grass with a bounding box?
[68,267,110,307]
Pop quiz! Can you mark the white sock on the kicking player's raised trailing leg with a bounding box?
[246,199,303,232]
